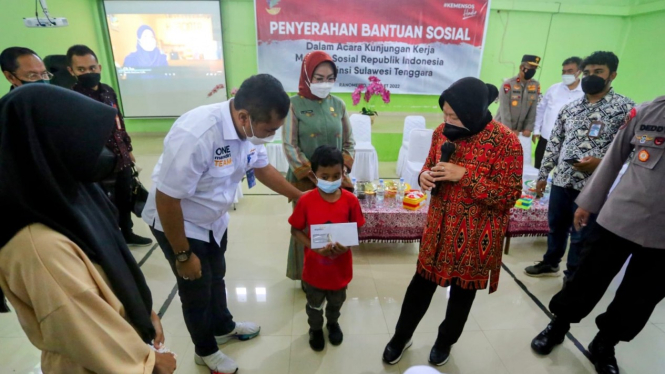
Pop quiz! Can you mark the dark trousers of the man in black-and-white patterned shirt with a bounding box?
[543,186,596,277]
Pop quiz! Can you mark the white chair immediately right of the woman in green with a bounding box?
[349,114,379,182]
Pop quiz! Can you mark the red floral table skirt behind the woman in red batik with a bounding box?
[359,196,549,246]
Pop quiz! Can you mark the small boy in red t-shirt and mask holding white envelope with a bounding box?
[289,145,365,351]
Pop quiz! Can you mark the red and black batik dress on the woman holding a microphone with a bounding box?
[417,121,522,293]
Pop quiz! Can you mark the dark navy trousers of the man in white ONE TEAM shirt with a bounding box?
[151,228,235,356]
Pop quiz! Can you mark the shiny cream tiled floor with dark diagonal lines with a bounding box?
[0,137,665,374]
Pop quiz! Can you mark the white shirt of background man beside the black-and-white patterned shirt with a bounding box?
[533,82,584,140]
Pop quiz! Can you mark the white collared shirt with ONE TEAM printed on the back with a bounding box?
[142,101,268,243]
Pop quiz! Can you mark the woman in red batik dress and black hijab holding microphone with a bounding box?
[383,78,522,366]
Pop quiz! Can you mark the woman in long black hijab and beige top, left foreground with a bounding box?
[0,85,175,373]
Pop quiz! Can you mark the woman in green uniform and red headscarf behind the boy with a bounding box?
[282,51,355,280]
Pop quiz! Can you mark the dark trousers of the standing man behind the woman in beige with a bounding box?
[100,167,134,238]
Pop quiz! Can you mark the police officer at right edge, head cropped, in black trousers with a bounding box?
[531,96,665,374]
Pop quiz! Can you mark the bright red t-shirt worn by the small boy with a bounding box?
[289,189,365,290]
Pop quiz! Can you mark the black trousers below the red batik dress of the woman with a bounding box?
[391,273,476,347]
